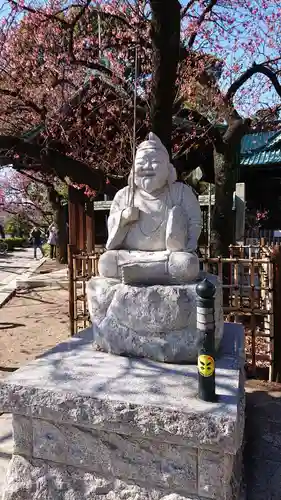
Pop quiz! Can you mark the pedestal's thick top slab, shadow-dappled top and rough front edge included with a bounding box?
[0,324,244,452]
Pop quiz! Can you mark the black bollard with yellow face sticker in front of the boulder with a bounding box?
[196,279,216,402]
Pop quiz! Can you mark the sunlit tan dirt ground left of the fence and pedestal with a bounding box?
[0,286,69,376]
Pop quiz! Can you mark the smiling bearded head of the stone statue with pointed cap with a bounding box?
[129,132,177,193]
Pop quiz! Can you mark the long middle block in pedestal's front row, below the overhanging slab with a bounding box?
[32,419,197,493]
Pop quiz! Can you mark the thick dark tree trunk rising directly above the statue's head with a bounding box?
[150,0,181,153]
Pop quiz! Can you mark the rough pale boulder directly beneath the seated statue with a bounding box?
[87,273,223,363]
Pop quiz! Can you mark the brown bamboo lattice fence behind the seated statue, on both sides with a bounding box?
[68,245,281,380]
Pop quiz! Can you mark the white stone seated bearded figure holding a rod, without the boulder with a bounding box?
[99,133,201,284]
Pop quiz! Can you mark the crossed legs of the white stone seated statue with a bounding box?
[99,250,199,285]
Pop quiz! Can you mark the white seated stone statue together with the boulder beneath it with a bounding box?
[87,134,223,363]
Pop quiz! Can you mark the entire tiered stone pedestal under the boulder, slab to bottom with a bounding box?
[0,324,244,500]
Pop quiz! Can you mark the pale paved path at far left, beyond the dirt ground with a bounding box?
[0,248,43,307]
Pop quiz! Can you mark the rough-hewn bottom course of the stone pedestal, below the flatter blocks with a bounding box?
[3,455,241,500]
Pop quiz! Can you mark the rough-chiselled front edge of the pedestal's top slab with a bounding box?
[0,382,240,454]
